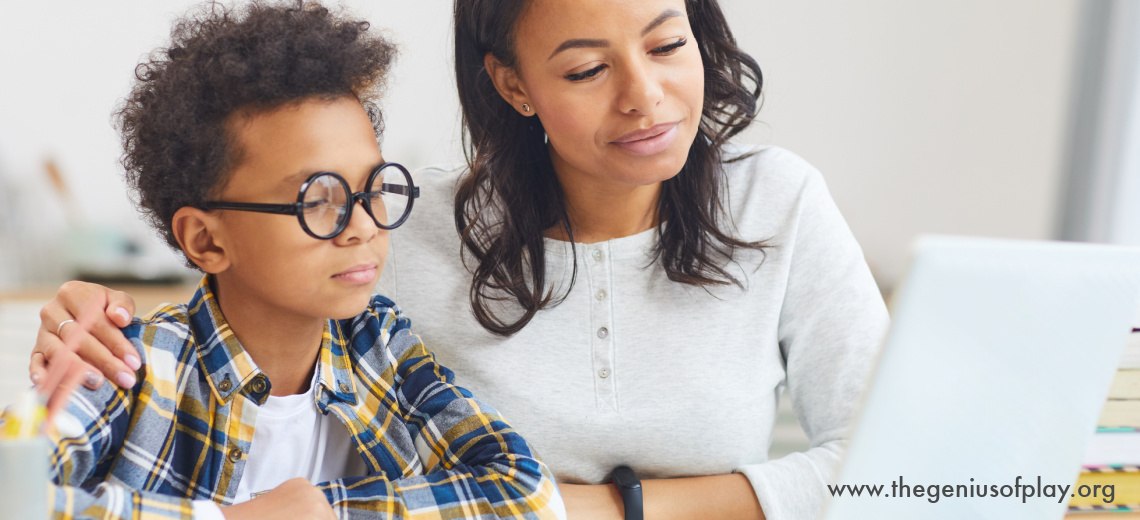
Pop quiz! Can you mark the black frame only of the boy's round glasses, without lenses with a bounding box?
[198,162,420,241]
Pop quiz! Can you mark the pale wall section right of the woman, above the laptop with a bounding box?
[727,0,1077,285]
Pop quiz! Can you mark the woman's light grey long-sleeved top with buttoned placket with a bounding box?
[377,143,888,520]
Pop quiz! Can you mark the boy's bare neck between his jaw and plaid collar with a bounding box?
[213,273,327,396]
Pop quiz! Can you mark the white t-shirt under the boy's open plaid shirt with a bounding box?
[194,371,368,520]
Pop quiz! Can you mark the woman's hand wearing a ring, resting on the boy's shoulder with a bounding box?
[29,282,141,390]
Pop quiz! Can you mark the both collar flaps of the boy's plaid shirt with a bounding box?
[187,275,357,405]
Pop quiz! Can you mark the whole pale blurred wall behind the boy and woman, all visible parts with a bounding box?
[0,0,1077,290]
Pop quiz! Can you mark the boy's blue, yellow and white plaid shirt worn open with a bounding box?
[51,278,565,519]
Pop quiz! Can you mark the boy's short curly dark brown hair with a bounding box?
[115,2,396,267]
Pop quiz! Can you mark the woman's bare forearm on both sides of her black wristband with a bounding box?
[559,473,765,520]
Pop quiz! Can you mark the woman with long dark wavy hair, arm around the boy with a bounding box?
[32,0,887,519]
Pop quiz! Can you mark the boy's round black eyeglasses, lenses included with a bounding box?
[200,162,420,239]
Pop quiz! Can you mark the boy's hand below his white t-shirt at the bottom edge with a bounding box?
[221,478,336,520]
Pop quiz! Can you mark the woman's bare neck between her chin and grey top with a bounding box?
[544,149,661,244]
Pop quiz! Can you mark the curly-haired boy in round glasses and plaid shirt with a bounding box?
[40,3,564,520]
